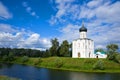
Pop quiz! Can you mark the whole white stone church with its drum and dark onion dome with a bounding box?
[72,24,95,58]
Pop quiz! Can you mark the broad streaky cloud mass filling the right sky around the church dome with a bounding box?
[50,0,120,48]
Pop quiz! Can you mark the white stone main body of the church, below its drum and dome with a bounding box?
[72,39,95,58]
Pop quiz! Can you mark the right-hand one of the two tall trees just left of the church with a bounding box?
[60,40,70,56]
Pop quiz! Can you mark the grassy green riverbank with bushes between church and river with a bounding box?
[0,57,120,73]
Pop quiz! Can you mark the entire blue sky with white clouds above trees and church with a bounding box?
[0,0,120,50]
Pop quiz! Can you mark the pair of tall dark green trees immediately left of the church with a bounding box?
[48,38,72,57]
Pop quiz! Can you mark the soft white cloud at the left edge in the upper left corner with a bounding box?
[0,2,12,19]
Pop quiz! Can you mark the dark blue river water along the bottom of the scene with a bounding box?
[0,64,120,80]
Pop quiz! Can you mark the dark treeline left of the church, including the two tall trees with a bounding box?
[0,38,72,57]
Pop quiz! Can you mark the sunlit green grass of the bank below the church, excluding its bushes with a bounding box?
[1,57,120,73]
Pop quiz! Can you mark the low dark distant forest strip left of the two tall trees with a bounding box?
[0,48,47,57]
